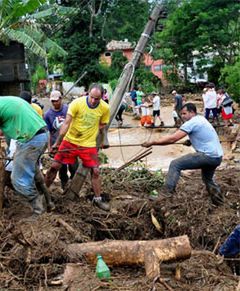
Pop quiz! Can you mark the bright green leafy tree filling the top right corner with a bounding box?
[155,0,240,82]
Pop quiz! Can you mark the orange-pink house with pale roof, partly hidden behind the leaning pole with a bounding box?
[100,39,166,83]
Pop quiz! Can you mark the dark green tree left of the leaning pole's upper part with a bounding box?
[52,0,149,86]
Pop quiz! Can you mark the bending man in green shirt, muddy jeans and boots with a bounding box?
[0,96,48,216]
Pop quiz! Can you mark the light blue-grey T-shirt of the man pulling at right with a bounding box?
[180,115,223,158]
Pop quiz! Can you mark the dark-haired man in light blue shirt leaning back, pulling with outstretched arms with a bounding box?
[142,103,223,205]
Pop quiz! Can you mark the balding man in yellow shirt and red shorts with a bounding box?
[45,84,110,210]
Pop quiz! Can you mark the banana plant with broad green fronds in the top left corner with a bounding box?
[0,0,73,58]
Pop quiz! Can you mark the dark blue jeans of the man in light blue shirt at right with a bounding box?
[165,152,222,191]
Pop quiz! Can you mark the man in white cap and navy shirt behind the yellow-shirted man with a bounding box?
[44,90,77,190]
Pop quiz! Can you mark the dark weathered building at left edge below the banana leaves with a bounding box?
[0,41,29,96]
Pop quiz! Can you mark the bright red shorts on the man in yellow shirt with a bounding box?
[54,140,99,168]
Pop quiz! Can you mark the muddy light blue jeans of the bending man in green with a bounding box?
[11,133,48,201]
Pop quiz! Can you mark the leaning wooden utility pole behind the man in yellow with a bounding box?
[66,0,164,197]
